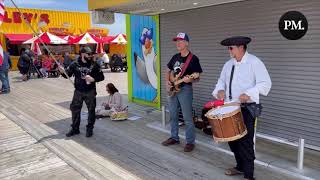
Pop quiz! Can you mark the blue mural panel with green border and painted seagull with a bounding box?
[127,15,160,107]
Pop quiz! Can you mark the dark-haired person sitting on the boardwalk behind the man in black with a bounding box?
[96,83,127,118]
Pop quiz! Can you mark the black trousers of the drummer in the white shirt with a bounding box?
[229,108,255,179]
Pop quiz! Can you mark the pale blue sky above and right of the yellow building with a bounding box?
[5,0,126,35]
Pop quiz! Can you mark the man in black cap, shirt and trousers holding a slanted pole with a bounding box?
[59,47,104,137]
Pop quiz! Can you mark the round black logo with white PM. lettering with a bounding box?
[279,11,308,40]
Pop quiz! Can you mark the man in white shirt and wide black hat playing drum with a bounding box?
[212,36,271,180]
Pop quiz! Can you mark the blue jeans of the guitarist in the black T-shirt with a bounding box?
[168,85,195,144]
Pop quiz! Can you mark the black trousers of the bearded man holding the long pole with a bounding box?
[70,89,97,130]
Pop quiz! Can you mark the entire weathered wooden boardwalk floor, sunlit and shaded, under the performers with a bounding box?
[0,73,304,180]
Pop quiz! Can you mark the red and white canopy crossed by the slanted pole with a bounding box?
[23,32,68,44]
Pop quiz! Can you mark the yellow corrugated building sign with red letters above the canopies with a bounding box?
[0,7,91,35]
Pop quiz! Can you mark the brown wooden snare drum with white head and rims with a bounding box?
[205,104,247,142]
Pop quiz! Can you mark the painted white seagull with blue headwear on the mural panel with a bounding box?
[133,28,158,89]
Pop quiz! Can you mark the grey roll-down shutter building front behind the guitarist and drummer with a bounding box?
[89,0,320,149]
